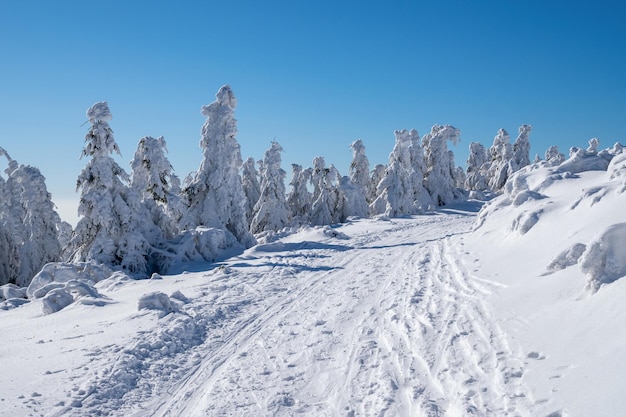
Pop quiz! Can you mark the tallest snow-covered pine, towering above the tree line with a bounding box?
[183,85,254,247]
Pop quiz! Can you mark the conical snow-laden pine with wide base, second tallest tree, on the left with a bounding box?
[66,102,158,274]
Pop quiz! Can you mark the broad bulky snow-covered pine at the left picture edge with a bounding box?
[0,148,65,287]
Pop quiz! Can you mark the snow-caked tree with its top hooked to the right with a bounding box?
[422,125,463,206]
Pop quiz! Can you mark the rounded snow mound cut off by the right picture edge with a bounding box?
[580,223,626,291]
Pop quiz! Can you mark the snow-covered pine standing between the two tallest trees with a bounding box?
[131,136,183,239]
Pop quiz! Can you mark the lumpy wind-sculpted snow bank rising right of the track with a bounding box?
[478,140,626,291]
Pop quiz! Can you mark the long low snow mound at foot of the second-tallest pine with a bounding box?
[26,262,113,298]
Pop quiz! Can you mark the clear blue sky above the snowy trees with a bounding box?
[0,0,626,222]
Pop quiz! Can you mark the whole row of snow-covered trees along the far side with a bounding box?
[0,85,544,286]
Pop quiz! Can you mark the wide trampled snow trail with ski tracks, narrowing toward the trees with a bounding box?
[48,214,533,417]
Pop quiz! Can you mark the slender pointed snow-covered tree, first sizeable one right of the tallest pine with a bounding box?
[250,142,289,233]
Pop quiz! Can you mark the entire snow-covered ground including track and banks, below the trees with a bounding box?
[0,156,626,417]
